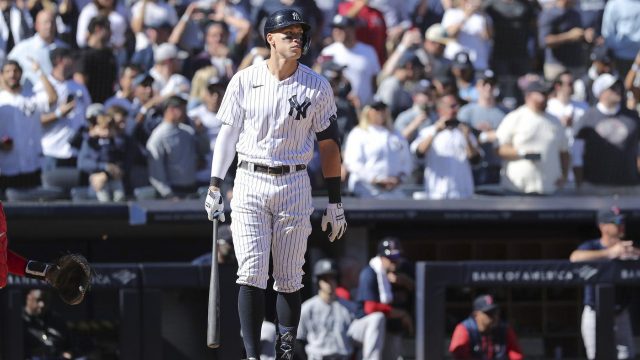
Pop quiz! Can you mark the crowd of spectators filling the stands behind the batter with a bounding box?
[0,0,640,201]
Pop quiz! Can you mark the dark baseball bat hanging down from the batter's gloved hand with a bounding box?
[207,219,220,349]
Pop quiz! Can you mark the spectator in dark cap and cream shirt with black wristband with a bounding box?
[496,79,569,194]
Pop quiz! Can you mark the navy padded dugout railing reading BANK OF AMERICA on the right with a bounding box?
[416,260,640,360]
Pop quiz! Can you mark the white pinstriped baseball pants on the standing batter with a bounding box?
[231,168,313,293]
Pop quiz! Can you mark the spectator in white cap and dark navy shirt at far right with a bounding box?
[572,74,640,194]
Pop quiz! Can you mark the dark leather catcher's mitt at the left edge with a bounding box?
[46,254,92,305]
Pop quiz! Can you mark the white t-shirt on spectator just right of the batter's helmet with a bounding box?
[321,42,380,106]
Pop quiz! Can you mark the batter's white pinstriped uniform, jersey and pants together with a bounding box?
[218,61,336,293]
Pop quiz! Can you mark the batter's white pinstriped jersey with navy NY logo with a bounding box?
[218,61,336,166]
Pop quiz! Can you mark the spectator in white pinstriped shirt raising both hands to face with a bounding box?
[411,94,479,199]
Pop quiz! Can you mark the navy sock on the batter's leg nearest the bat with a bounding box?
[238,285,264,359]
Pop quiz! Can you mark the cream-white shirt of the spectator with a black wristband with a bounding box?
[496,105,569,194]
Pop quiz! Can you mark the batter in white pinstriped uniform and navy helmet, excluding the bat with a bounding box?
[205,9,347,359]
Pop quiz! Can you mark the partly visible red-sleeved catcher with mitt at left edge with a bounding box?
[0,203,91,305]
